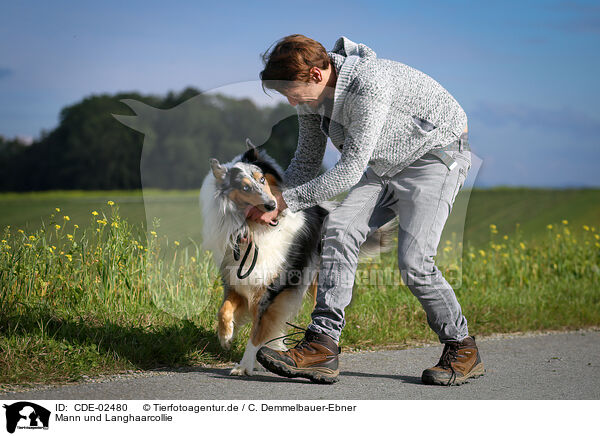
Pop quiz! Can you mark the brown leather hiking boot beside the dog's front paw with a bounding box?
[256,330,340,384]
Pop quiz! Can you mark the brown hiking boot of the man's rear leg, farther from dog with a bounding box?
[421,336,485,386]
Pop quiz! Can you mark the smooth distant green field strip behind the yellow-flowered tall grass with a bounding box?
[0,188,600,245]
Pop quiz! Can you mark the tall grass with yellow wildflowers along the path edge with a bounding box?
[0,201,600,385]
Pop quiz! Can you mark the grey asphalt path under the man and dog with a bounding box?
[0,331,600,400]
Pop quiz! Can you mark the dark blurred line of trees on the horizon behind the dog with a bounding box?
[0,88,298,191]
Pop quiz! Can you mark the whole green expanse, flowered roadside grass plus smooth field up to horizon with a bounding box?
[0,189,600,389]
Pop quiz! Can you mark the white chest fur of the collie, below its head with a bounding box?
[223,212,304,297]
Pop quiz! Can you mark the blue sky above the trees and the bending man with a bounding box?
[0,0,600,186]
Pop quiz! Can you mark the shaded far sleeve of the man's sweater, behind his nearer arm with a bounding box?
[283,108,327,187]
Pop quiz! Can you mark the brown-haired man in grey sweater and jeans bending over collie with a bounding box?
[249,35,484,385]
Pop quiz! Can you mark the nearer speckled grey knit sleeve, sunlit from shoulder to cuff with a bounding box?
[282,82,392,212]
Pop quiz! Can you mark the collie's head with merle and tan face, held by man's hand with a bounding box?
[210,139,281,212]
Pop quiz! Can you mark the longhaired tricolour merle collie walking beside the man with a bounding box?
[200,140,396,376]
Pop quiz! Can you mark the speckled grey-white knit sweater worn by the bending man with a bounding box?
[282,36,467,212]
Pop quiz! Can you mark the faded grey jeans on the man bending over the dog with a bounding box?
[308,135,471,342]
